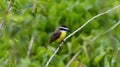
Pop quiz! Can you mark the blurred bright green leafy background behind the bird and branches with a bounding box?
[0,0,120,67]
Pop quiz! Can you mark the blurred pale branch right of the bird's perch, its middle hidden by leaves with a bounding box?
[66,21,120,67]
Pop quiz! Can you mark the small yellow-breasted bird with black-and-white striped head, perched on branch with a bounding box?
[49,26,70,44]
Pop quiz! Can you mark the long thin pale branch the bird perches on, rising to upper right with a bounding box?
[45,5,120,67]
